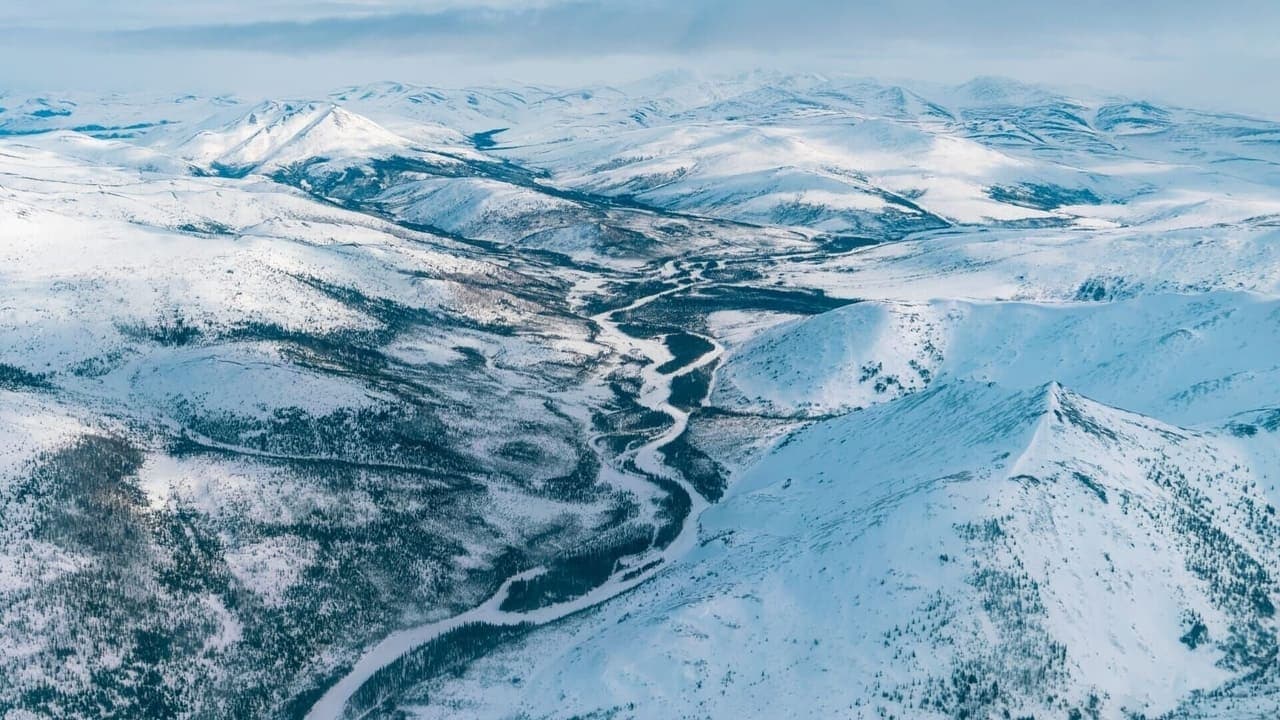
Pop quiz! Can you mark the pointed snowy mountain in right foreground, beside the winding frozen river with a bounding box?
[420,382,1276,717]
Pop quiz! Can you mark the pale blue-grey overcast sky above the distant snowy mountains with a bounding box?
[0,0,1280,115]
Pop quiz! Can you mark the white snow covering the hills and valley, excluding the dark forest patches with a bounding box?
[0,73,1280,719]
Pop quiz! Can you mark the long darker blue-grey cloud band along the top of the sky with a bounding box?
[64,0,1280,56]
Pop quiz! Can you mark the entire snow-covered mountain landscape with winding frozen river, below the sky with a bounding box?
[0,73,1280,720]
